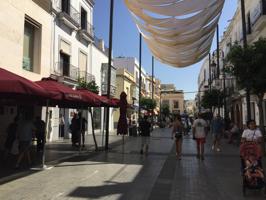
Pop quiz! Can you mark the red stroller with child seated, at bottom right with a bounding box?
[240,142,266,195]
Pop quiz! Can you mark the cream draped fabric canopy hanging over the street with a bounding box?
[124,0,224,67]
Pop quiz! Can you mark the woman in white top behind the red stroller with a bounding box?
[241,120,262,143]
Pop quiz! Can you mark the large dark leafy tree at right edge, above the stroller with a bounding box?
[226,38,266,151]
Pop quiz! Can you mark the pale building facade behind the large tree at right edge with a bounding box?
[217,0,266,126]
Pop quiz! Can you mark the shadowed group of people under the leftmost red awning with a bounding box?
[4,113,45,168]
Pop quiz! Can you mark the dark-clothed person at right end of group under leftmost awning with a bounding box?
[34,116,45,152]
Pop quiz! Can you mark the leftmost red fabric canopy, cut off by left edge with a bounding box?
[0,68,49,98]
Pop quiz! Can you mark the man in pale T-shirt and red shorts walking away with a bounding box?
[192,113,208,160]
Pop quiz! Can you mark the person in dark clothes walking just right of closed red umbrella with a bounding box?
[139,115,151,154]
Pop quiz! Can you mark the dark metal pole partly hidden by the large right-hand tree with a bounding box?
[240,0,251,121]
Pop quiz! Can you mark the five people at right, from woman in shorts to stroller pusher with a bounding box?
[172,113,262,164]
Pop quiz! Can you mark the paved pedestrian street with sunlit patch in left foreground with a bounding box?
[0,129,266,200]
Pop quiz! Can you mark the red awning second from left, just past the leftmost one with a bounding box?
[36,78,98,107]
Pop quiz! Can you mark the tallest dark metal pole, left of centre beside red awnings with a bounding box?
[105,0,114,150]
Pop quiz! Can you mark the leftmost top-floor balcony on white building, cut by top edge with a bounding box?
[53,0,80,30]
